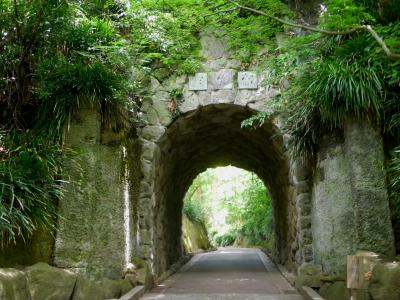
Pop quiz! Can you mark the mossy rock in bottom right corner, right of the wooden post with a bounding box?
[370,262,400,300]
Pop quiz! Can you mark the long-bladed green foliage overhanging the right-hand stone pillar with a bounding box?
[250,0,400,159]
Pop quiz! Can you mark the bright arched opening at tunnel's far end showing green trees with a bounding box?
[182,166,275,254]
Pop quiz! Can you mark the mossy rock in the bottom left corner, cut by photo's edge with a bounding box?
[0,268,31,300]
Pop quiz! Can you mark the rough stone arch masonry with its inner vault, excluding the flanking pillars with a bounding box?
[138,30,312,274]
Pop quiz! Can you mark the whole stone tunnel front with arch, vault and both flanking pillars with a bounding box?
[48,29,394,278]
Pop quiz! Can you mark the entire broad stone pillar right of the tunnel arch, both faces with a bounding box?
[312,122,394,274]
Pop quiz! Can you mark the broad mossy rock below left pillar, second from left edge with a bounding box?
[26,263,76,300]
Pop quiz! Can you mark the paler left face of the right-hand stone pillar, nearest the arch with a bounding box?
[311,135,356,273]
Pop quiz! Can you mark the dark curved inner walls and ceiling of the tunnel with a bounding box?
[154,104,295,274]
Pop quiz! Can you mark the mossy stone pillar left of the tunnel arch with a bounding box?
[54,108,134,279]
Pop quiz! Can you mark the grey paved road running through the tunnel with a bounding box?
[142,248,303,300]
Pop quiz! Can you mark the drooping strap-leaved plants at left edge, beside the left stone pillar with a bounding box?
[0,130,63,245]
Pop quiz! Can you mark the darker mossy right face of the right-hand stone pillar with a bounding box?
[344,122,395,256]
